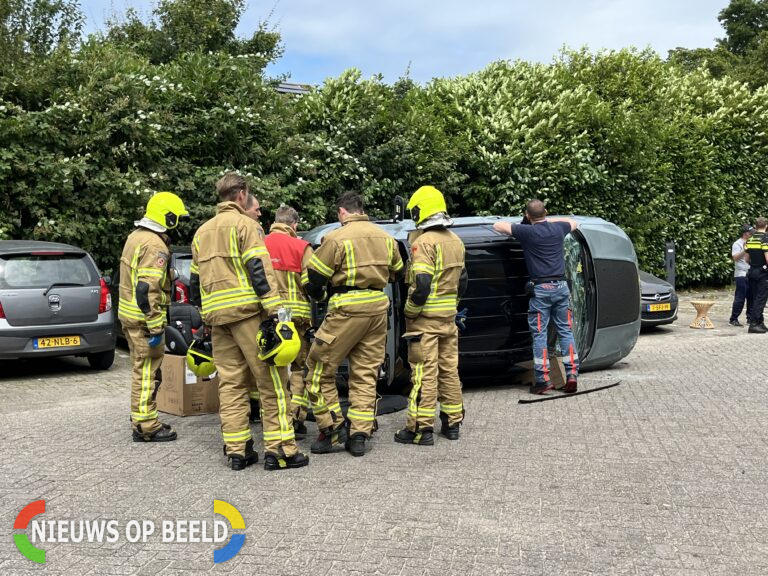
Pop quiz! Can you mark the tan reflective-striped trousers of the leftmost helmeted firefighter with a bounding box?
[123,326,165,434]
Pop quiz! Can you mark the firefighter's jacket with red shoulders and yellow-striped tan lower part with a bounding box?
[264,223,314,321]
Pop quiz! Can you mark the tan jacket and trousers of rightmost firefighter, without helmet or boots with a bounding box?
[403,228,464,432]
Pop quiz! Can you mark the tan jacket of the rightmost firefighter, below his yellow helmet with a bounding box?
[405,228,467,319]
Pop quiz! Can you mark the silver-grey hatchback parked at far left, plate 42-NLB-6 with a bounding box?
[0,240,115,370]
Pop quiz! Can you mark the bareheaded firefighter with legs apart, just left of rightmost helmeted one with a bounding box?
[306,192,403,456]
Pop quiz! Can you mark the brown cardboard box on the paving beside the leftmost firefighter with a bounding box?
[157,354,219,416]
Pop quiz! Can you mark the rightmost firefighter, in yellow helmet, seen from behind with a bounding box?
[395,186,467,446]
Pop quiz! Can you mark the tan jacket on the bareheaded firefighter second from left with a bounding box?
[190,202,282,326]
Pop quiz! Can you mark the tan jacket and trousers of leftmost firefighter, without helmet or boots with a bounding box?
[117,228,171,434]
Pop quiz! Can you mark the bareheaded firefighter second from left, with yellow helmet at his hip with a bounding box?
[190,173,309,470]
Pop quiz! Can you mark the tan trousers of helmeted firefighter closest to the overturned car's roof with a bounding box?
[403,316,464,432]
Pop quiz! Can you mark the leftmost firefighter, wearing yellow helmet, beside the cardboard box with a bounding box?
[117,192,189,442]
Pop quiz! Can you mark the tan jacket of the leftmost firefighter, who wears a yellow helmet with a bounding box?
[117,227,171,334]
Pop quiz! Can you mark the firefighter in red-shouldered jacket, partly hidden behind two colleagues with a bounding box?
[264,206,314,438]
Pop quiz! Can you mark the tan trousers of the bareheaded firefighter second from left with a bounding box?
[211,312,297,456]
